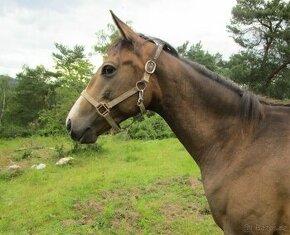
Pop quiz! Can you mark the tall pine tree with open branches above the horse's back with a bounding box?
[227,0,290,98]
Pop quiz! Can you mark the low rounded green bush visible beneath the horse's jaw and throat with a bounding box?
[127,114,174,140]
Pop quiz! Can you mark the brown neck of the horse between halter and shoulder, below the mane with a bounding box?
[154,54,244,166]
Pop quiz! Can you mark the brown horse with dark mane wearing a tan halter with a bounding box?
[66,12,290,235]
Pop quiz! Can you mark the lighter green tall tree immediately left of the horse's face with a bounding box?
[38,43,94,134]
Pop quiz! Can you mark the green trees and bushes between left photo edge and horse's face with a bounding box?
[0,43,94,137]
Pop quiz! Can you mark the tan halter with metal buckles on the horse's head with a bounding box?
[81,40,164,132]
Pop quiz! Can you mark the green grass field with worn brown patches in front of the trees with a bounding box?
[0,135,221,235]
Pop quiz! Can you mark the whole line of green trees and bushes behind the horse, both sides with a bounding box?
[0,0,290,139]
